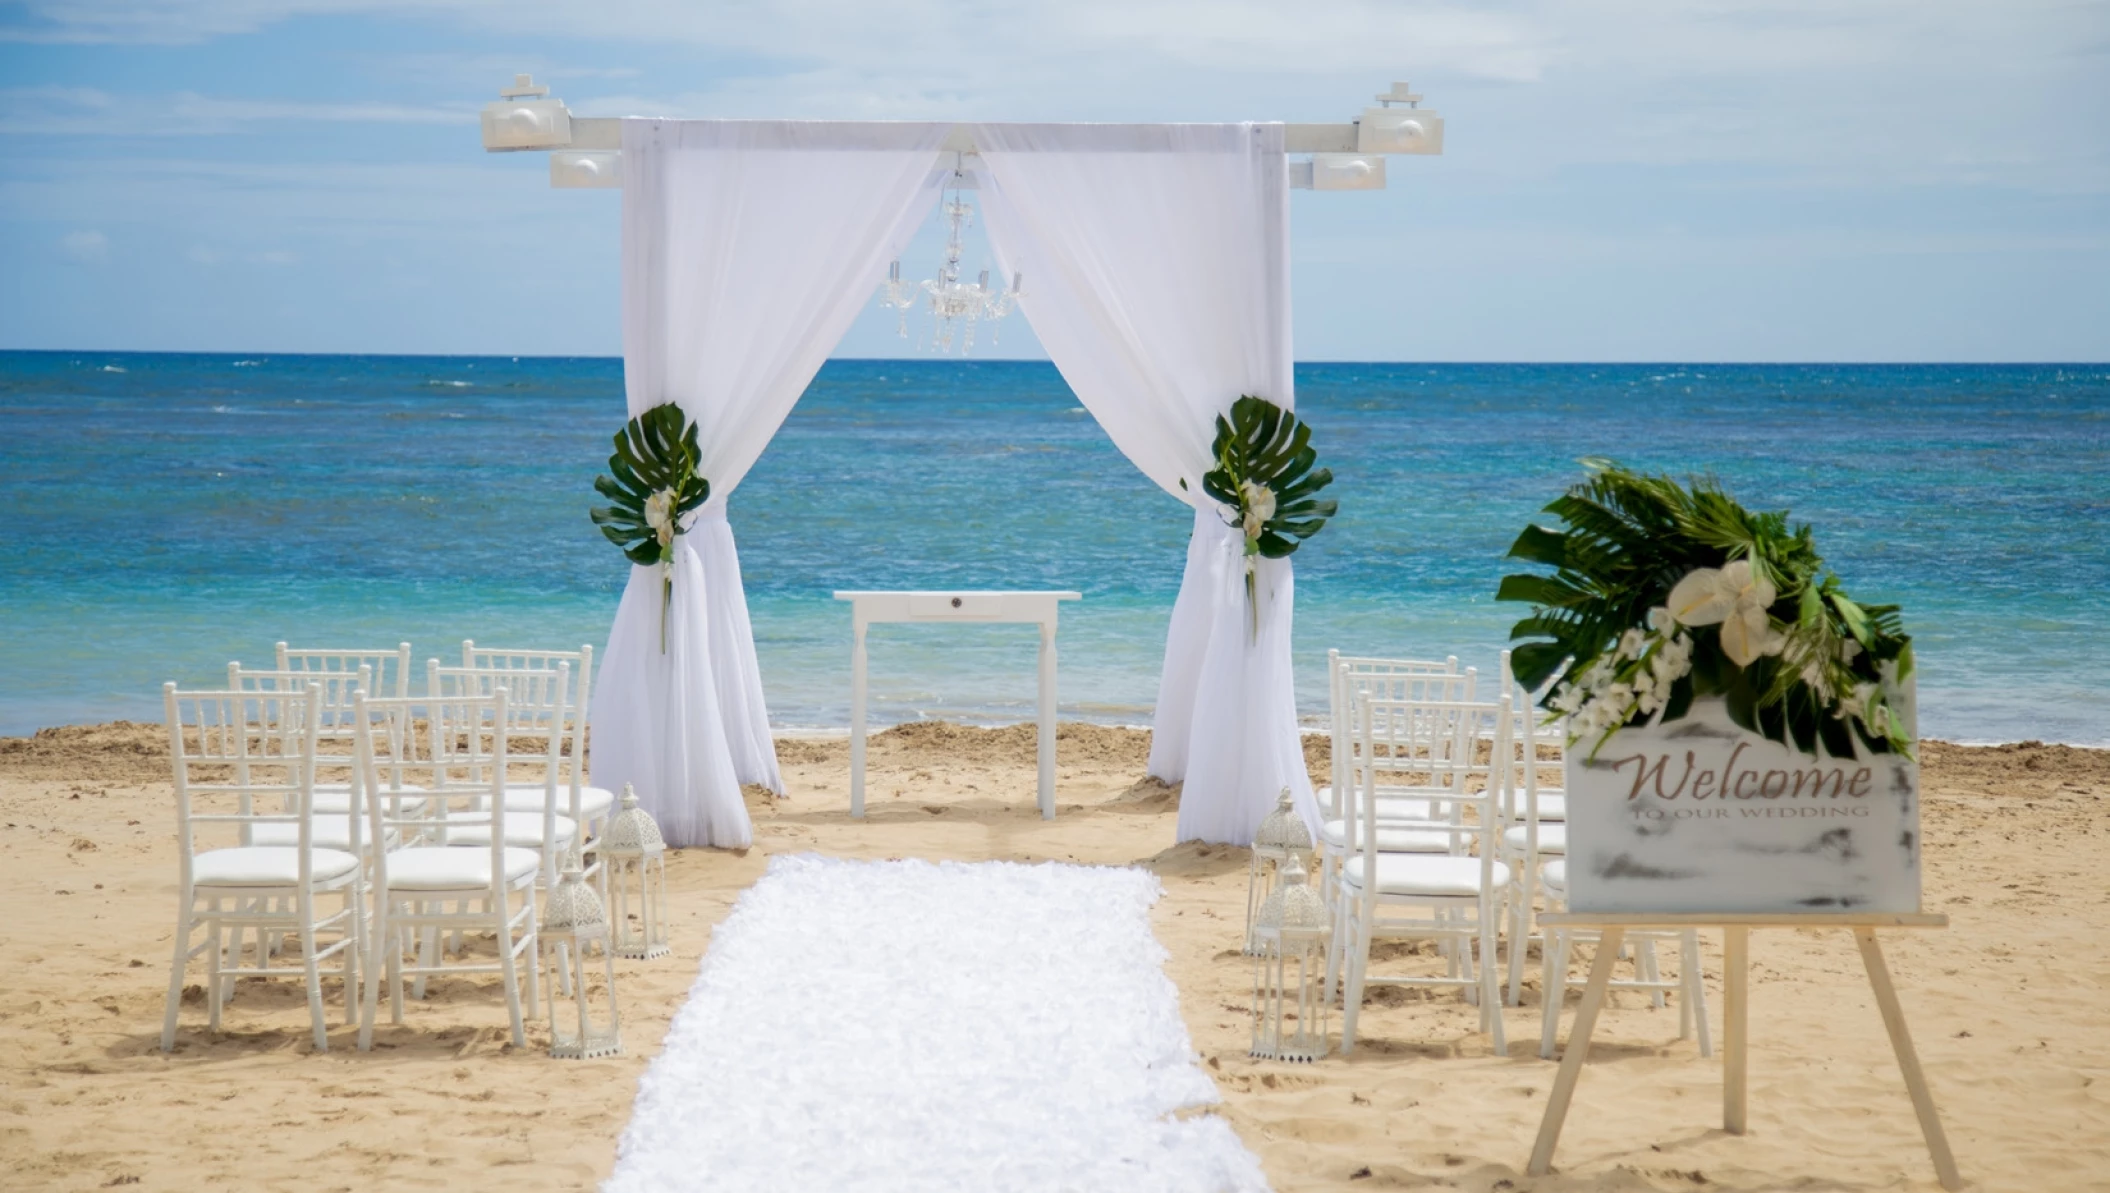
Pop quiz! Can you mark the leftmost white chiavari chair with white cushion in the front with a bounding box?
[160,684,365,1052]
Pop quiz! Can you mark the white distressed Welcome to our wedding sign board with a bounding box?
[1566,680,1920,914]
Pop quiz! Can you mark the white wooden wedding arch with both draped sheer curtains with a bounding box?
[483,76,1441,847]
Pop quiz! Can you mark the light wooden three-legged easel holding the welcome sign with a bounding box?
[1526,912,1964,1191]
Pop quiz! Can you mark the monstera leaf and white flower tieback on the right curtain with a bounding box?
[1179,397,1340,638]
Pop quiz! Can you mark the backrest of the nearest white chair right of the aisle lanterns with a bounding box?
[1346,697,1515,870]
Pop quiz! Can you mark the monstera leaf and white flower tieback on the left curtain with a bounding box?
[591,401,711,655]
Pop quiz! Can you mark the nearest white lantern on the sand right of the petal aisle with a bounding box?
[1251,855,1331,1062]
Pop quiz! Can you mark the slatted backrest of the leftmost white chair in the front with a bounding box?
[160,684,324,889]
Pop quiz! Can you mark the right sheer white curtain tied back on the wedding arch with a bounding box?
[973,125,1317,845]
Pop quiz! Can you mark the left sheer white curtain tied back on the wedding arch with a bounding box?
[593,120,952,847]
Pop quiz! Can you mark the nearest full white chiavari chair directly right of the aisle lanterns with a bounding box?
[1327,697,1511,1054]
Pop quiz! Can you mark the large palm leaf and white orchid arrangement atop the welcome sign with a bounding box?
[1496,460,1912,758]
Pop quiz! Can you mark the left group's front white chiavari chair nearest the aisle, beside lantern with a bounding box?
[354,688,542,1049]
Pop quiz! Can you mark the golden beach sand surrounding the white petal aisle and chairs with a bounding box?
[0,724,2110,1193]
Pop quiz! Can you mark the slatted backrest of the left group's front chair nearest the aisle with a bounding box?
[352,688,511,900]
